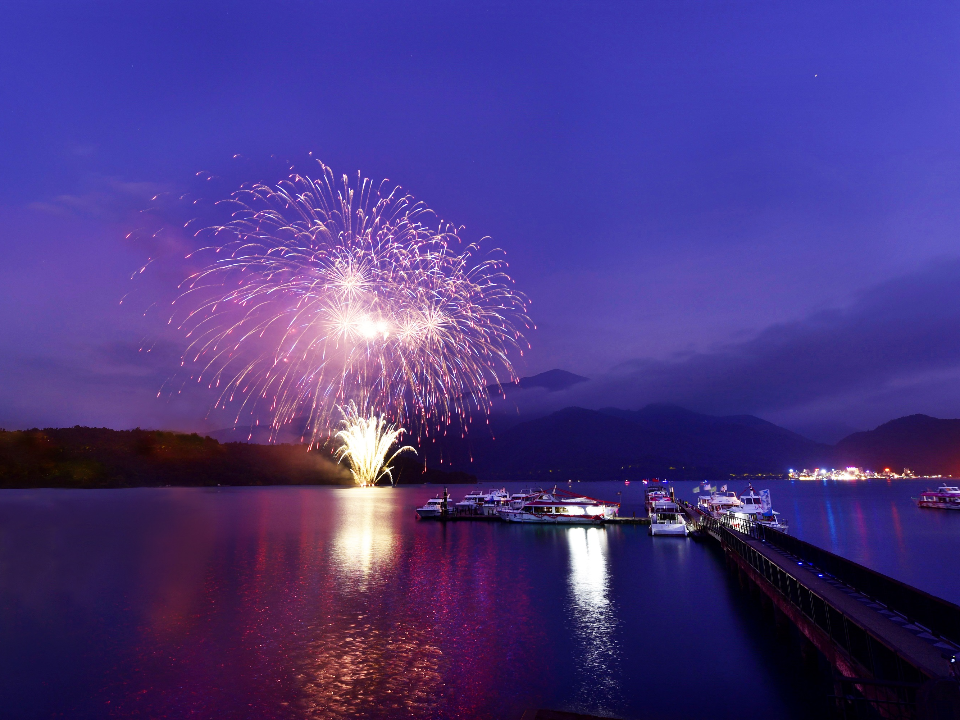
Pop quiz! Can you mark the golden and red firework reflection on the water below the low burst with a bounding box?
[296,488,443,718]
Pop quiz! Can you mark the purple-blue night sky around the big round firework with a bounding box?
[0,0,960,440]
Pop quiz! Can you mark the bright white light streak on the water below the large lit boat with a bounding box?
[567,528,620,711]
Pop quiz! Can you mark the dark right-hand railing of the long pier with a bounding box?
[695,512,960,644]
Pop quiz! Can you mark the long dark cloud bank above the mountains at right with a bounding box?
[496,258,960,434]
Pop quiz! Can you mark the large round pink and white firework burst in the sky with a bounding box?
[176,164,531,458]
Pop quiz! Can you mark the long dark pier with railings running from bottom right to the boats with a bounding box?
[683,503,960,720]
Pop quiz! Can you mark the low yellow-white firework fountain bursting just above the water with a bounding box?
[336,401,413,487]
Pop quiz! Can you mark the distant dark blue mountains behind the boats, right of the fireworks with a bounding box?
[204,369,960,482]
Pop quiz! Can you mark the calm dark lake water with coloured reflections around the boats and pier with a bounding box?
[0,481,960,720]
